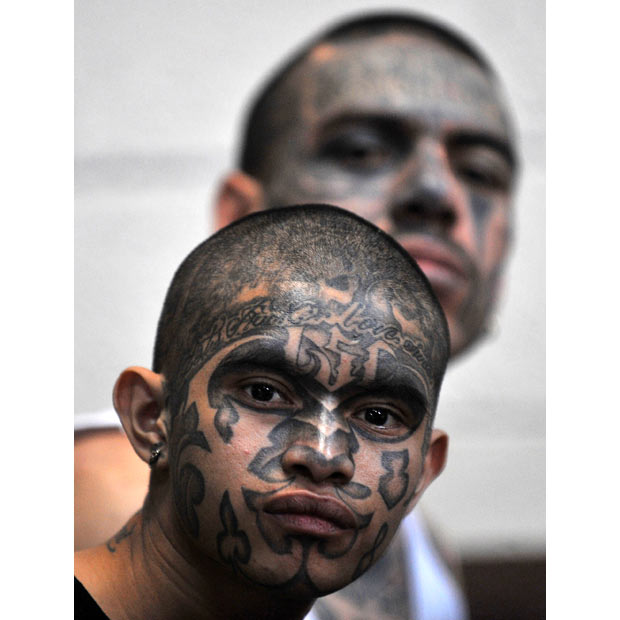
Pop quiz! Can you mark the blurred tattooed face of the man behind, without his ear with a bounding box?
[254,33,514,354]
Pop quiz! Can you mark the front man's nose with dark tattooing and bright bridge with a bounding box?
[281,421,357,484]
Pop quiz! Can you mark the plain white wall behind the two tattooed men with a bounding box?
[75,0,545,555]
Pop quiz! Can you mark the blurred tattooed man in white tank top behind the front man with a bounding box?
[75,14,516,620]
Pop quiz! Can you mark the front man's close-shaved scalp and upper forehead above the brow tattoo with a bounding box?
[153,205,449,422]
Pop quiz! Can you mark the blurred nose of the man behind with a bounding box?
[390,137,466,234]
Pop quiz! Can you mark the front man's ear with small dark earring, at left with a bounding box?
[113,366,168,467]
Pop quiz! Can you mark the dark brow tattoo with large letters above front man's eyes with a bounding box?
[194,324,434,416]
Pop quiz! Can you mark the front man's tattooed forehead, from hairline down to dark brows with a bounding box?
[182,279,436,392]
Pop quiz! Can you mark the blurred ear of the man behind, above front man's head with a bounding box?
[214,170,265,230]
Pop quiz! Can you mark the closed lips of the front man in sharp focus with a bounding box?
[263,492,357,536]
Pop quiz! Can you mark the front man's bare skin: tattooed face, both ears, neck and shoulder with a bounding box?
[76,274,447,619]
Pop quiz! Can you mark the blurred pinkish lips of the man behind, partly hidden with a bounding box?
[398,236,468,290]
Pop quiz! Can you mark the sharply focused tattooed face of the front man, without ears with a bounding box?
[165,280,446,597]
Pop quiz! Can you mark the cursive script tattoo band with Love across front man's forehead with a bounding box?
[171,274,447,415]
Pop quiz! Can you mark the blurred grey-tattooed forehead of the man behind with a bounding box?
[301,33,508,134]
